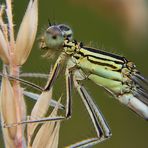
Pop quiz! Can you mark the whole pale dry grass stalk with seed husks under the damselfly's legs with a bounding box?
[0,0,60,148]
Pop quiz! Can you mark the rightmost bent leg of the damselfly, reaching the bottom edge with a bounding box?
[69,78,111,148]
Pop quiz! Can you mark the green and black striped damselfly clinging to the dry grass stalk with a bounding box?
[2,24,148,147]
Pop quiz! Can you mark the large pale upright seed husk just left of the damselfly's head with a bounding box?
[15,0,38,65]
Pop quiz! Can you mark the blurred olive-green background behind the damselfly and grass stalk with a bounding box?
[0,0,148,148]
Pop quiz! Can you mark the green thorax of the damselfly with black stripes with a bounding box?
[63,40,137,97]
